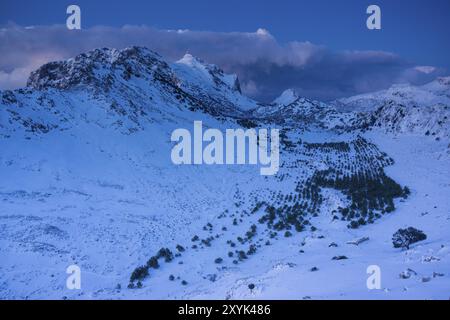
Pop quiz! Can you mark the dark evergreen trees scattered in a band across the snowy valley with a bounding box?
[125,135,408,287]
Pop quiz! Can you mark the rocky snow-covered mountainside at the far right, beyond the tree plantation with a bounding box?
[332,77,450,140]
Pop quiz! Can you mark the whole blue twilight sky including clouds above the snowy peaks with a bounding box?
[0,0,450,100]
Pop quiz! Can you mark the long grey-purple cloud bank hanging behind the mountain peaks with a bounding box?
[0,25,443,101]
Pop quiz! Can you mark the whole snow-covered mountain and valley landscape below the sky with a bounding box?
[0,47,450,299]
